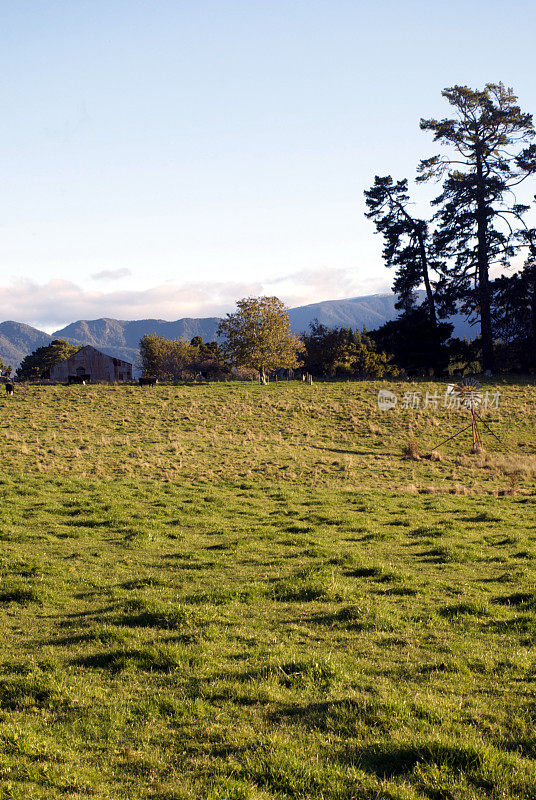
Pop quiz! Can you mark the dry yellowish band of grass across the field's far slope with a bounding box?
[0,381,536,494]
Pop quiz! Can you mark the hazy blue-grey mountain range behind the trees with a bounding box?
[0,294,475,369]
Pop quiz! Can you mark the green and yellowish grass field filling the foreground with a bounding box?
[0,382,536,800]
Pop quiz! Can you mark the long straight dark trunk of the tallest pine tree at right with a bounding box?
[476,158,495,372]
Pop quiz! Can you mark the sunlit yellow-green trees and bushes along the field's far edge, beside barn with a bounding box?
[12,297,400,383]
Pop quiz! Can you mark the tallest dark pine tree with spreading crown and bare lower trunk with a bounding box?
[417,83,536,370]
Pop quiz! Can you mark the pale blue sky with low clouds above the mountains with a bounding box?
[0,0,536,331]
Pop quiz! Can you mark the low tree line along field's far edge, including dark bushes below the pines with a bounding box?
[10,286,522,383]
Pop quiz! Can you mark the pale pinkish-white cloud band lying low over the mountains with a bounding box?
[0,269,388,331]
